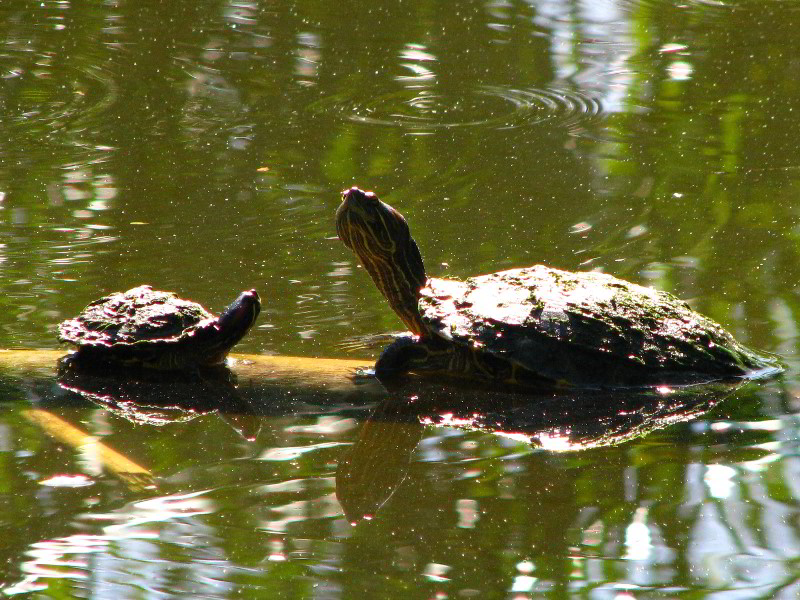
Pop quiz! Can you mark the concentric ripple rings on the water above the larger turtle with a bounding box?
[310,86,603,130]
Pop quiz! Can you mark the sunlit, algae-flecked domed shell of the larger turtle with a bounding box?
[419,265,774,384]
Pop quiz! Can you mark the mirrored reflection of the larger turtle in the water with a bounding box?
[336,380,746,525]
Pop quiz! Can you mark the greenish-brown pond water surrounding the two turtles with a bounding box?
[0,0,800,600]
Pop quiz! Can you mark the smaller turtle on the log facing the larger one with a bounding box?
[58,285,261,371]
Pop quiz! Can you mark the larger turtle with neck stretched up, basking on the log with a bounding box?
[336,187,779,387]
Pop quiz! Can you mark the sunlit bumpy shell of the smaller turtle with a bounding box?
[59,285,214,348]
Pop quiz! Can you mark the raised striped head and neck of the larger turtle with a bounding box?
[336,187,428,335]
